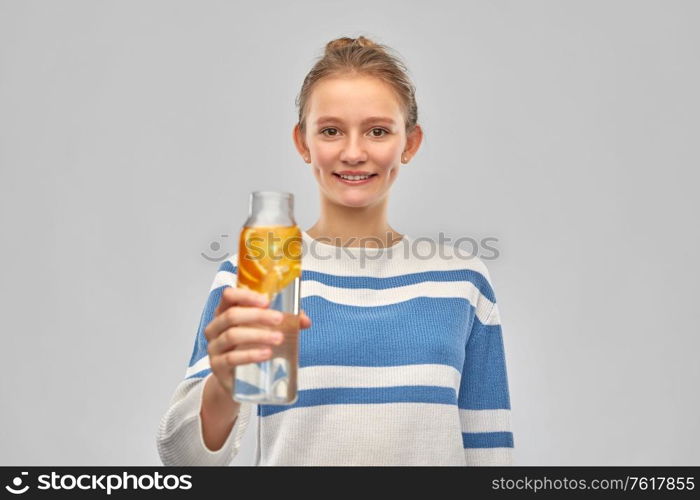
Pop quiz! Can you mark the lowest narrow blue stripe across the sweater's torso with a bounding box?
[258,385,456,417]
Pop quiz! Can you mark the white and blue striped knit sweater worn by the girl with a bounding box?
[157,231,513,465]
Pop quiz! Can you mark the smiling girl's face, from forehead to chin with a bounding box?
[296,76,406,207]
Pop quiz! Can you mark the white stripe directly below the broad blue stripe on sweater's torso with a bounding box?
[298,364,460,392]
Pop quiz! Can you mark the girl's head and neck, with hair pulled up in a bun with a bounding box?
[293,41,423,246]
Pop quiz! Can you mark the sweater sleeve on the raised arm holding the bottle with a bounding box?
[156,255,253,466]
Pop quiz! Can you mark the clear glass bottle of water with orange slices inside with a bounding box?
[233,191,302,404]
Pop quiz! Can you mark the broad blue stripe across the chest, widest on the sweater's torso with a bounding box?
[299,296,474,372]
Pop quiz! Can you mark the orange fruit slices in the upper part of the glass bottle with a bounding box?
[238,226,302,300]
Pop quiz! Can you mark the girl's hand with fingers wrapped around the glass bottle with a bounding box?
[204,287,311,394]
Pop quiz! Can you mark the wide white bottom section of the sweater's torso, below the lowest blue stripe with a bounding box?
[255,402,465,466]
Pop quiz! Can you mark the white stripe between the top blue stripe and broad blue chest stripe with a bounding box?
[301,280,493,323]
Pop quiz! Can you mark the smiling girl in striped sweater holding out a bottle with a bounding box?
[157,36,513,465]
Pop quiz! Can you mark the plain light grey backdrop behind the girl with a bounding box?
[0,0,700,465]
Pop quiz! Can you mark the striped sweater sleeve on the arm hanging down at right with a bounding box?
[458,270,513,466]
